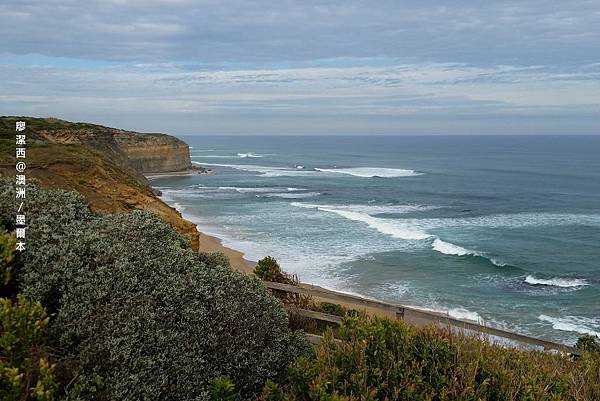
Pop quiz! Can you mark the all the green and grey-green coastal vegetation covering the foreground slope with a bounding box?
[0,180,600,401]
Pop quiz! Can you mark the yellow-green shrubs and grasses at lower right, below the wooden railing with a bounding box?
[271,318,600,401]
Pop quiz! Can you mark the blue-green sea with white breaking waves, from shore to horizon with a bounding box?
[153,136,600,343]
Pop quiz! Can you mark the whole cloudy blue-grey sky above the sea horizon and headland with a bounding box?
[0,0,600,135]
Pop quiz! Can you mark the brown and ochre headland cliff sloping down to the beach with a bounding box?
[0,117,204,249]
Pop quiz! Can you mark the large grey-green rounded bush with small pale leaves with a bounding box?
[0,182,307,401]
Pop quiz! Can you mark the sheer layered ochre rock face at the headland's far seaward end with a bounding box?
[114,133,192,174]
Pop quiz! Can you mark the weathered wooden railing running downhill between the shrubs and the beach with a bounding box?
[263,281,579,355]
